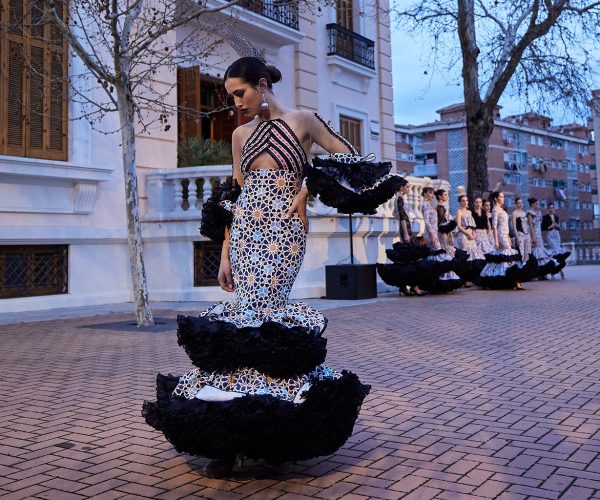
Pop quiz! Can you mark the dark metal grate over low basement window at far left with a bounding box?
[0,245,69,299]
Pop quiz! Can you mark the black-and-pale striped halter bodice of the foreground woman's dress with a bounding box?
[240,118,308,175]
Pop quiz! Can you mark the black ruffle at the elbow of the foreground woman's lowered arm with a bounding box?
[200,178,241,244]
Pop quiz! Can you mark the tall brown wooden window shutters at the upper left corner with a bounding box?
[0,0,68,160]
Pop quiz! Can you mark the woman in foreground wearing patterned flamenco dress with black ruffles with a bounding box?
[142,57,384,477]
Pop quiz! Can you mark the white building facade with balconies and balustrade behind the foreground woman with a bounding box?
[0,0,406,312]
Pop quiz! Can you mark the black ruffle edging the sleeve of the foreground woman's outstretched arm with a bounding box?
[306,160,407,215]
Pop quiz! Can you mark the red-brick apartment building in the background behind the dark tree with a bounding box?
[396,103,600,241]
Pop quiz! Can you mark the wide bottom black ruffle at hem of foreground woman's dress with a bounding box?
[142,372,370,464]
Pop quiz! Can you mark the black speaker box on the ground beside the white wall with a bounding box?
[325,264,377,300]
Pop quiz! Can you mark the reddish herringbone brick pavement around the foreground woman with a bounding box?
[0,266,600,500]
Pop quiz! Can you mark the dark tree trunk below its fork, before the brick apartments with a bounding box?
[466,104,494,200]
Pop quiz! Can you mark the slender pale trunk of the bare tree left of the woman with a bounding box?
[115,82,154,326]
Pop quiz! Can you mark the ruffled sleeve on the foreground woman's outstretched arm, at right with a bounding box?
[306,115,407,215]
